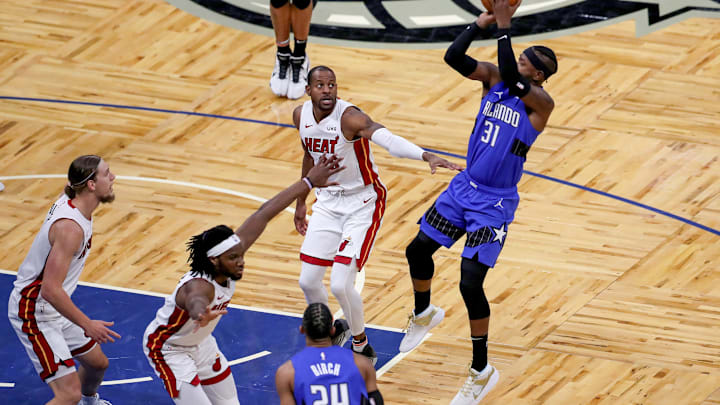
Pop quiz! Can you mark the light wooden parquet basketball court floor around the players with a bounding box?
[0,0,720,405]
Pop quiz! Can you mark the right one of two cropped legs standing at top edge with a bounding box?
[287,0,313,99]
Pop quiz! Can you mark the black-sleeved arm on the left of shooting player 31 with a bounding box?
[445,13,500,91]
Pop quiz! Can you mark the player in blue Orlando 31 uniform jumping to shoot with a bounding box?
[400,0,557,405]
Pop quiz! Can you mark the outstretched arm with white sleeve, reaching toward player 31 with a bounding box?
[342,108,462,173]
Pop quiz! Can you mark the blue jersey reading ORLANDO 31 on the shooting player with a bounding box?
[467,82,540,188]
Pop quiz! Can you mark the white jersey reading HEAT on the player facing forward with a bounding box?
[299,99,384,192]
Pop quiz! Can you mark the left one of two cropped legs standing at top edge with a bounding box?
[270,0,292,97]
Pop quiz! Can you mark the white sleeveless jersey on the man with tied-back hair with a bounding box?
[13,194,92,318]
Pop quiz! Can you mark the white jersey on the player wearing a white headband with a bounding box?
[145,272,235,350]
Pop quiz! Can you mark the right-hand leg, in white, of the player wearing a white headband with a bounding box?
[196,336,240,405]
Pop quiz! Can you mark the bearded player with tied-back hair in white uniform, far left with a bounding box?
[8,155,120,405]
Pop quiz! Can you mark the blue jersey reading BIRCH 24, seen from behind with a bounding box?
[291,346,367,405]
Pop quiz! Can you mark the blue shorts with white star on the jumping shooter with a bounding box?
[420,171,519,267]
